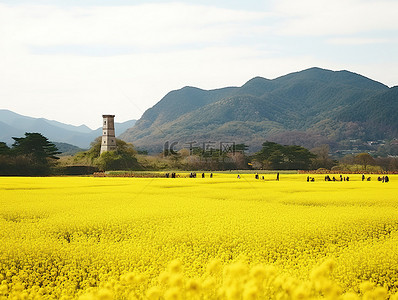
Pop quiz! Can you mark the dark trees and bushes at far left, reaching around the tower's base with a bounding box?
[0,133,142,176]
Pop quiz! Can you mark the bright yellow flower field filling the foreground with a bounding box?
[0,174,398,299]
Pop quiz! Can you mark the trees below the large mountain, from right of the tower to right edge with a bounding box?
[146,141,398,172]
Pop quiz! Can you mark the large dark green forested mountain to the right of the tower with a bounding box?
[120,68,398,152]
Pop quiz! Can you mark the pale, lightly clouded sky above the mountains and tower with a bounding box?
[0,0,398,129]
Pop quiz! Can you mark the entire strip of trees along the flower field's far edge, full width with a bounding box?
[0,133,398,176]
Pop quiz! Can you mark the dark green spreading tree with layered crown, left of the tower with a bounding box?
[12,132,60,164]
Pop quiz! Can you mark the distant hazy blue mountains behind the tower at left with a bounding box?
[0,109,135,149]
